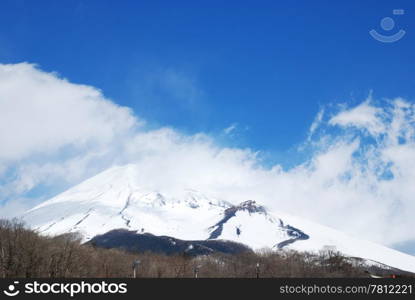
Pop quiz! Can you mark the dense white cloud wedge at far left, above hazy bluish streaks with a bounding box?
[0,63,137,161]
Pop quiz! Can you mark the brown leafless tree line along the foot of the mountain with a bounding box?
[0,220,390,278]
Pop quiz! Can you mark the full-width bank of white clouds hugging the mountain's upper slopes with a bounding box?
[0,63,415,245]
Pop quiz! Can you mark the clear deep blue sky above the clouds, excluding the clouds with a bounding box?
[0,1,415,164]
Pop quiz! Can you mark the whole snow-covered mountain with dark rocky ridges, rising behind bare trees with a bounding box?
[22,165,415,272]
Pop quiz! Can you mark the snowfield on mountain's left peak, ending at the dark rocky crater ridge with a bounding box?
[23,165,230,241]
